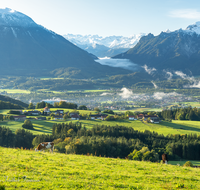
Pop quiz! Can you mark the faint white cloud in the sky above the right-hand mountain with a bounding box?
[169,9,200,19]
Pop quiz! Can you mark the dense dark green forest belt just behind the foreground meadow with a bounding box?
[34,123,200,161]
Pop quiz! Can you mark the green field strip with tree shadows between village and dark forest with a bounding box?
[0,118,200,135]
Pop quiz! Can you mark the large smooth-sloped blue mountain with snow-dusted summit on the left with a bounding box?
[0,8,130,78]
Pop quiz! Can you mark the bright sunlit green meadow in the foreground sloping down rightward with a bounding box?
[0,147,200,190]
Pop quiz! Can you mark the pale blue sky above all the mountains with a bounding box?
[0,0,200,37]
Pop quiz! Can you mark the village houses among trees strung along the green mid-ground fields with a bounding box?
[10,107,160,123]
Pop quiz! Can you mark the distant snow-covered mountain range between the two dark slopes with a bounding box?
[64,34,145,57]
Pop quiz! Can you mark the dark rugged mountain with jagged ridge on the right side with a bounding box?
[113,22,200,75]
